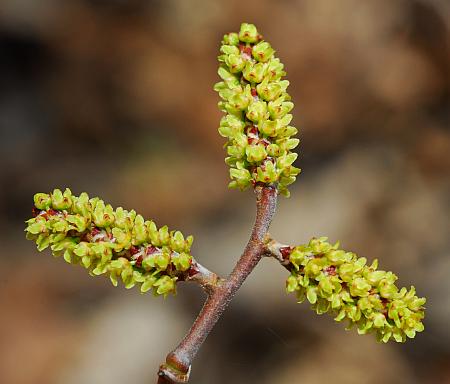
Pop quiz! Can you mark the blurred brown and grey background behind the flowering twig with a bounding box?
[0,0,450,384]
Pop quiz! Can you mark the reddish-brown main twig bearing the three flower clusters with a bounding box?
[158,186,277,384]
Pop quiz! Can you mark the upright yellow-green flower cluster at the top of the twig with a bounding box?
[214,23,300,196]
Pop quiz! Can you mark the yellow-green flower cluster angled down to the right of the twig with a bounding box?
[284,237,426,343]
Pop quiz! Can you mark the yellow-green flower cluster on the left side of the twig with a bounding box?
[25,189,193,296]
